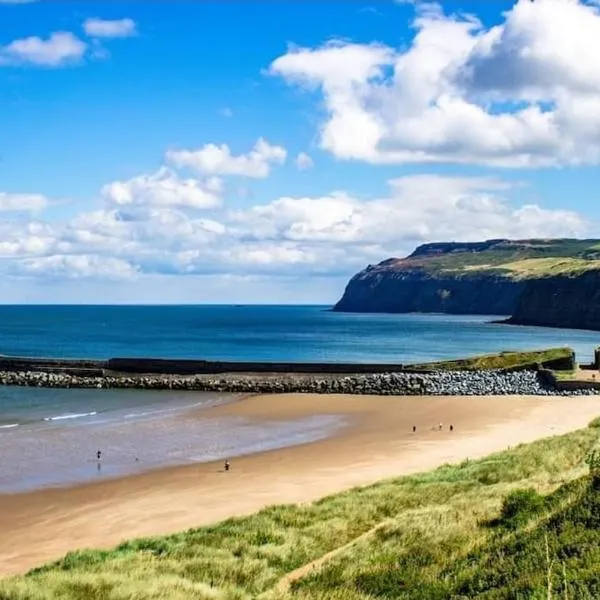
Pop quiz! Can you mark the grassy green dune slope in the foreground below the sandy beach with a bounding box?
[0,418,600,600]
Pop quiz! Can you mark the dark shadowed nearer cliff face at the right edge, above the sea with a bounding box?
[507,271,600,330]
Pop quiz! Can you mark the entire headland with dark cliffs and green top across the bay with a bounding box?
[334,239,600,328]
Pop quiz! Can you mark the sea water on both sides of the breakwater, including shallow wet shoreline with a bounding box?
[0,305,600,493]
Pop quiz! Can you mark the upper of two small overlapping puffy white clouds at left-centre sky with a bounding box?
[166,138,287,179]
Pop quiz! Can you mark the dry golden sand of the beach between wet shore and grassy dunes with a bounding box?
[0,394,600,575]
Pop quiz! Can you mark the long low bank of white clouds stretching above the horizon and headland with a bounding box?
[0,168,588,278]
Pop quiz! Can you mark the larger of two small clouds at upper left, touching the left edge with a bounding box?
[0,31,87,67]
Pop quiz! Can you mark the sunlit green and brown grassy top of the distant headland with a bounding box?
[395,239,600,280]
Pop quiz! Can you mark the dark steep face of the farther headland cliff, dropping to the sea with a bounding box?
[334,268,524,315]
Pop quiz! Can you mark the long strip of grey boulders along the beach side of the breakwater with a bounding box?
[0,371,598,396]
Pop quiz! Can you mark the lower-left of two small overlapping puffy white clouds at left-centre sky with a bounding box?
[102,167,222,209]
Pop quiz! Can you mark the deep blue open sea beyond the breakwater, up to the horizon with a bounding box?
[0,305,600,363]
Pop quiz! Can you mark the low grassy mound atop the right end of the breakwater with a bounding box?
[408,348,575,371]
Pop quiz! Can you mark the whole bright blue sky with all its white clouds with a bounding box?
[0,0,600,303]
